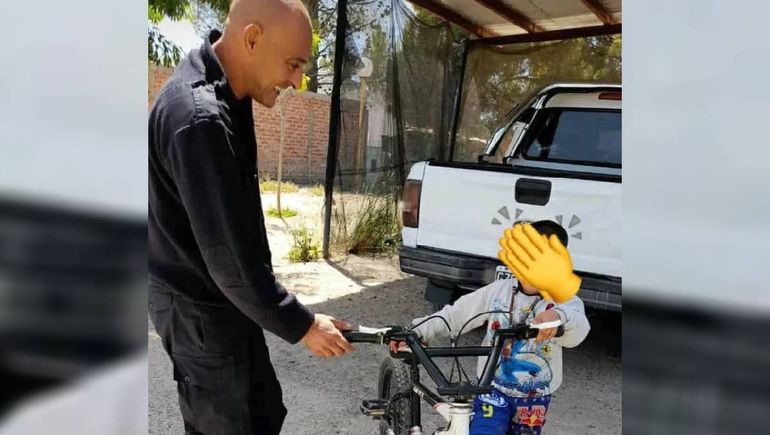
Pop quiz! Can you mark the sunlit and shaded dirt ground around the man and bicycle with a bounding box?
[148,190,622,435]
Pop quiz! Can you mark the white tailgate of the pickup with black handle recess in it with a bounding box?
[417,165,622,277]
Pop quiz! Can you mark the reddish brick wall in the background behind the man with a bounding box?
[148,64,367,184]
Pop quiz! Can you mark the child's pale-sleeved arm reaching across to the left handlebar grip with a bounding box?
[412,280,500,341]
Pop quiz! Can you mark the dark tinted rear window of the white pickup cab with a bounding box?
[522,108,622,168]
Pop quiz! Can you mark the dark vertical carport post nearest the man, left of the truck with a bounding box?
[323,0,348,259]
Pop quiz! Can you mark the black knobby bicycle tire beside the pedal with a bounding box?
[377,357,412,435]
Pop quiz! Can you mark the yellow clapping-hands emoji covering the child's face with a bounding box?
[498,224,581,303]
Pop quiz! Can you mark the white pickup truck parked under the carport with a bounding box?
[399,84,622,311]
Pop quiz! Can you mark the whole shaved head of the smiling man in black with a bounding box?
[215,0,313,107]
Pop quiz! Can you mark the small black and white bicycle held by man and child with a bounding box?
[342,311,564,435]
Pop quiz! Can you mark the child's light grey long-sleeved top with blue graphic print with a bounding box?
[412,278,590,397]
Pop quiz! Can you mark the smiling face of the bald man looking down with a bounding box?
[247,14,313,107]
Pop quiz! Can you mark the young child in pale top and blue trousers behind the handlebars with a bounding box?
[391,221,590,435]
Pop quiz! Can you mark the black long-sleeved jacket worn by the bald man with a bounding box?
[149,31,313,343]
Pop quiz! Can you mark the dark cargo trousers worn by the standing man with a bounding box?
[149,288,286,435]
